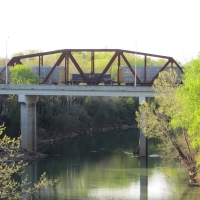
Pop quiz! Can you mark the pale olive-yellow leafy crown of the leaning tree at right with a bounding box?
[136,71,178,137]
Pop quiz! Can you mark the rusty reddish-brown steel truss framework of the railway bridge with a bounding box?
[1,49,182,86]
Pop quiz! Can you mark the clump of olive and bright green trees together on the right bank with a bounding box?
[137,59,200,186]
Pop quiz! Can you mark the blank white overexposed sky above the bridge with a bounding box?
[0,0,200,63]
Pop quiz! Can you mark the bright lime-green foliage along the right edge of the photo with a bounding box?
[172,58,200,148]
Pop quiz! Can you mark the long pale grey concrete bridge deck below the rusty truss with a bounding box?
[0,84,153,97]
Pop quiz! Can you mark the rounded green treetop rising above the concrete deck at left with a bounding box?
[10,65,41,85]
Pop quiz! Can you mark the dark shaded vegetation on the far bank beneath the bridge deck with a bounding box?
[0,96,138,137]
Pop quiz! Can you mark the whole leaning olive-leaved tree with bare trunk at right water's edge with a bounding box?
[136,70,200,185]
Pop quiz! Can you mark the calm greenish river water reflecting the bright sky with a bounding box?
[25,130,200,200]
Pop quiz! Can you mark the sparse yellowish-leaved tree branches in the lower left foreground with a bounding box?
[0,125,57,199]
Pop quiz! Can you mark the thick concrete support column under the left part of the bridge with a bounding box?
[18,95,38,151]
